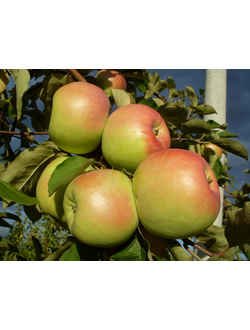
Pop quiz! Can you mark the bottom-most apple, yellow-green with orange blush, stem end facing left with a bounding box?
[63,169,139,248]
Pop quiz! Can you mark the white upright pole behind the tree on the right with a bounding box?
[205,69,227,227]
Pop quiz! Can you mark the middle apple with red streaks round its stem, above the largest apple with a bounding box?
[102,104,171,173]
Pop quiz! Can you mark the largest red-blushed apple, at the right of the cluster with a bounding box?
[133,149,221,239]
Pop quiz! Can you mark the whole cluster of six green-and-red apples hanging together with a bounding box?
[37,69,220,248]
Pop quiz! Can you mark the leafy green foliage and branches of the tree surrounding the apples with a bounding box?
[0,69,250,261]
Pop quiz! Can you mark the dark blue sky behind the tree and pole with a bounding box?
[0,69,250,236]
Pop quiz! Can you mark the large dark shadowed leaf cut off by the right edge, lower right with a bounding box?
[225,202,250,247]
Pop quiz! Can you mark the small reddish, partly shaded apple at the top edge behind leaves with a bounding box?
[96,69,127,96]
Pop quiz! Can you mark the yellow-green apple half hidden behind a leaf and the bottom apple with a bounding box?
[36,157,69,229]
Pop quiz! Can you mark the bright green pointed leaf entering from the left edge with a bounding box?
[0,180,38,205]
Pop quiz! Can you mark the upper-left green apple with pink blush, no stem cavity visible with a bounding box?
[49,82,110,154]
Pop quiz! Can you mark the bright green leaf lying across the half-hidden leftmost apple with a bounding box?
[48,156,96,196]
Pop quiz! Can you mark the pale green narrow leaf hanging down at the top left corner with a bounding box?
[8,69,30,120]
